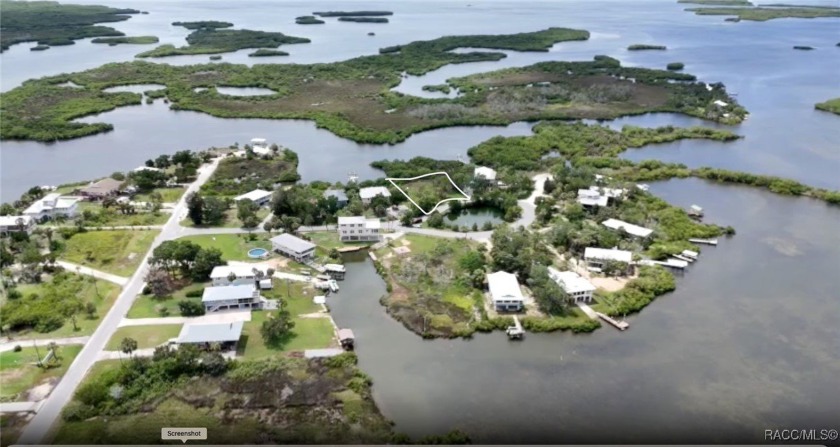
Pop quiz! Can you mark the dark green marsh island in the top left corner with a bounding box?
[0,0,140,51]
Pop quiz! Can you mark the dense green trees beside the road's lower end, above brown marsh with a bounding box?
[62,343,232,421]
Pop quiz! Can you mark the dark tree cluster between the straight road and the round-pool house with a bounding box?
[149,239,226,281]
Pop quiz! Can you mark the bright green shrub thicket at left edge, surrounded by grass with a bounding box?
[0,272,102,332]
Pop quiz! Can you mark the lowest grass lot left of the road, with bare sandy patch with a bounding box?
[0,345,82,401]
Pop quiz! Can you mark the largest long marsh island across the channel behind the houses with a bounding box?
[0,28,746,143]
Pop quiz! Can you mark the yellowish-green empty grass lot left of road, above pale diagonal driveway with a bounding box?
[60,230,158,277]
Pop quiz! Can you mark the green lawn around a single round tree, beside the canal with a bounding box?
[238,311,335,360]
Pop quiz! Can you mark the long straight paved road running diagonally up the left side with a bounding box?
[18,158,221,444]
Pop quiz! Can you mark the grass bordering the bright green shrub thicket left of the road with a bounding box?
[15,274,120,338]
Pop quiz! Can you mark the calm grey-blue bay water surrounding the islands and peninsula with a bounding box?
[0,0,840,442]
